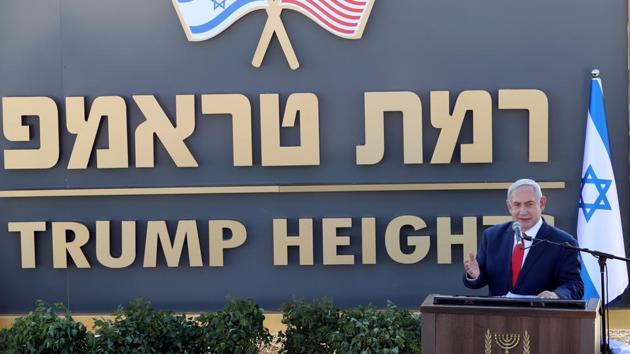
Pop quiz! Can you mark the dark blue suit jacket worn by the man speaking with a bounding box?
[464,221,584,300]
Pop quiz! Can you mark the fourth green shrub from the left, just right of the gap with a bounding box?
[278,298,339,354]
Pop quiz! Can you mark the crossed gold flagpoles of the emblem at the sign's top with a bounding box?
[252,0,300,70]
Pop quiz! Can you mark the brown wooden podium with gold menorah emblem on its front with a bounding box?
[420,295,600,354]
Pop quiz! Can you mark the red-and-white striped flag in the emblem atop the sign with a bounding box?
[280,0,374,39]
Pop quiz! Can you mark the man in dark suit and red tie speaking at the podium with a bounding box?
[463,179,584,299]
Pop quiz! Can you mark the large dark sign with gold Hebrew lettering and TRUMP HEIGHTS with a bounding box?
[0,0,630,313]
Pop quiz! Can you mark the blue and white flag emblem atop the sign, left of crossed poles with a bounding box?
[173,0,268,42]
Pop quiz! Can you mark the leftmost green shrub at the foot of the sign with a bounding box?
[0,300,89,354]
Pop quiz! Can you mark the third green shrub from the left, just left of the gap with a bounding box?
[197,300,271,354]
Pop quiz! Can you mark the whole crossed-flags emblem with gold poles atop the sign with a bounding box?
[172,0,375,70]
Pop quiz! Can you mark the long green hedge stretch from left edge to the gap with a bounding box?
[0,300,271,354]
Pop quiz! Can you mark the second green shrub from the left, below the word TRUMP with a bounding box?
[90,299,202,354]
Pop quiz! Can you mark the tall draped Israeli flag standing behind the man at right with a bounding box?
[577,73,628,302]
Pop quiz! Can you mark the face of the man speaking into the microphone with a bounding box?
[507,186,547,231]
